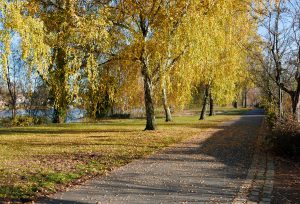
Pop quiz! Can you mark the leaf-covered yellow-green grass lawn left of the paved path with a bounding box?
[0,110,245,200]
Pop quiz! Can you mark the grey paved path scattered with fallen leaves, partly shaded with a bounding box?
[40,111,265,204]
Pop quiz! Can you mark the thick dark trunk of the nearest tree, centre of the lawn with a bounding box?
[142,63,156,130]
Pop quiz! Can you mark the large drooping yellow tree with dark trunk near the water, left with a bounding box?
[4,0,110,123]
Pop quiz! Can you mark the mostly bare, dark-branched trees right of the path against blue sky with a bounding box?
[253,0,300,121]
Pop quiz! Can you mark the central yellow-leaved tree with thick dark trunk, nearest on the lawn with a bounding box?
[113,0,189,130]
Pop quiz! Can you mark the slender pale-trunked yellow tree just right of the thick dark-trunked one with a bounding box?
[153,1,192,122]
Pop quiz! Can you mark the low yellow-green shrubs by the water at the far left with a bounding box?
[1,116,48,127]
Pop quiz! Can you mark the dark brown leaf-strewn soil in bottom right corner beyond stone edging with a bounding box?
[272,156,300,204]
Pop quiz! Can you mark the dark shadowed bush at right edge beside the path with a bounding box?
[268,116,300,155]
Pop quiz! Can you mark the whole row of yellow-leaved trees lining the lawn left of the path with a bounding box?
[0,0,259,130]
